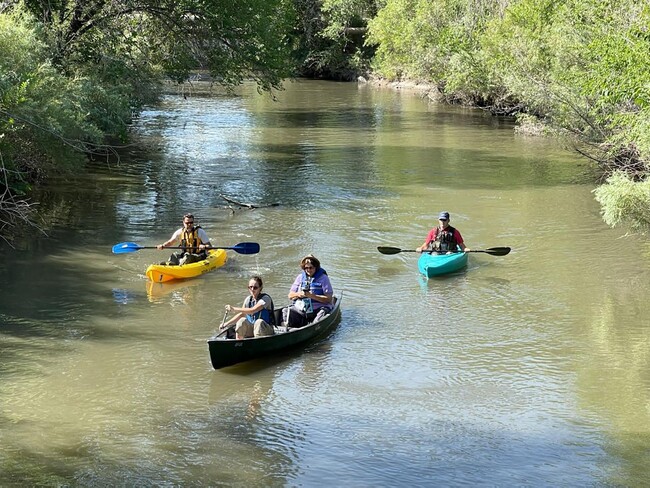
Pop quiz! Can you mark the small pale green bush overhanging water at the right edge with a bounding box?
[594,171,650,234]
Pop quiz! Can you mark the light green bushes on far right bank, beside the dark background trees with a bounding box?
[368,0,503,105]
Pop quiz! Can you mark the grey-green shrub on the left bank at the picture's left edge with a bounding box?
[0,8,92,182]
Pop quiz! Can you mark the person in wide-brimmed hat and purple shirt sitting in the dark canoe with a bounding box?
[284,254,334,327]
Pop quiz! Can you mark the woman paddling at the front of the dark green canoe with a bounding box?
[219,276,275,339]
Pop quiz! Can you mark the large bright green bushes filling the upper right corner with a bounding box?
[481,0,650,166]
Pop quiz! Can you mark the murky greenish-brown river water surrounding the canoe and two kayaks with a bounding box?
[0,82,650,487]
